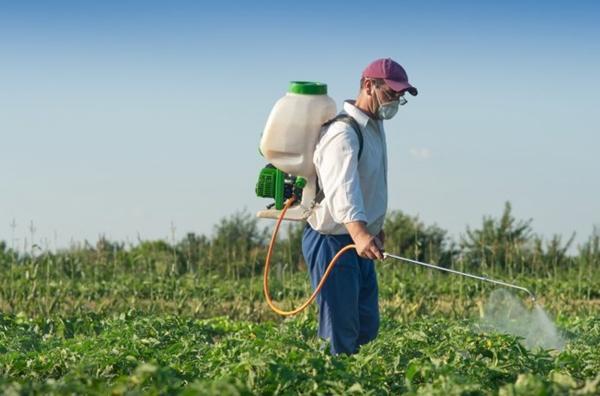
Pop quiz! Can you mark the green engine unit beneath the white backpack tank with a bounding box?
[256,164,306,210]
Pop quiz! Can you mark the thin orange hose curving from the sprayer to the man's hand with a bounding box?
[263,196,356,316]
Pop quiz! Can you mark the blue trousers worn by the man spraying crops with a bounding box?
[302,224,379,355]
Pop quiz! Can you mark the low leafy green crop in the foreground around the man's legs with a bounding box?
[0,311,600,395]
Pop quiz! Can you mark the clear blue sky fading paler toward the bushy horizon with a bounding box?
[0,0,600,251]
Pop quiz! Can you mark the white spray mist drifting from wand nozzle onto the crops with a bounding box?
[482,289,565,350]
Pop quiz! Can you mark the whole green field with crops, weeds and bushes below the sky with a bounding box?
[0,205,600,395]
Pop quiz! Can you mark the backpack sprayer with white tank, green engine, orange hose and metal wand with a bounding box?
[255,81,535,316]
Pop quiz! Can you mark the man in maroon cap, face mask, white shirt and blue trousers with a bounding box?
[302,58,417,355]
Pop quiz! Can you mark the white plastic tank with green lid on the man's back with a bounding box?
[260,81,337,177]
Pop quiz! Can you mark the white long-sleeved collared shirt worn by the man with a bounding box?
[308,101,388,235]
